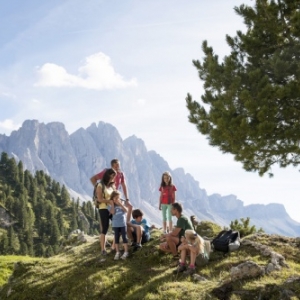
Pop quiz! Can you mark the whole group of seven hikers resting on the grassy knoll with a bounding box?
[90,159,209,274]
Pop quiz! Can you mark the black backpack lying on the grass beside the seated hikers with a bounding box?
[211,229,240,253]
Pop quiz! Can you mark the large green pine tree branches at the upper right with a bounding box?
[186,0,300,176]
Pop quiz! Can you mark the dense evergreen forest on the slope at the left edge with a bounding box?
[0,152,99,257]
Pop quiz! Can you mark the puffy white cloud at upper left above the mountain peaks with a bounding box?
[35,52,137,90]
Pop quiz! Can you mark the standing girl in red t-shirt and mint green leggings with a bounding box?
[158,172,177,234]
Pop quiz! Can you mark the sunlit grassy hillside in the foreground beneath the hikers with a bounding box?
[0,230,300,300]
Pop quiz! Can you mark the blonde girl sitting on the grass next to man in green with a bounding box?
[175,229,206,275]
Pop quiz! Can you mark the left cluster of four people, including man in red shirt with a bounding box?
[90,159,153,260]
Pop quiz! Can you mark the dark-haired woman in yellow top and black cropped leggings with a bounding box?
[96,169,117,255]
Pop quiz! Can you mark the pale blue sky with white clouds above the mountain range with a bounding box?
[0,0,300,222]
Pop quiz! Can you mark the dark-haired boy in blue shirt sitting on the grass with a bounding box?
[127,209,154,251]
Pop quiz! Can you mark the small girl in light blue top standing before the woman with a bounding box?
[109,191,128,260]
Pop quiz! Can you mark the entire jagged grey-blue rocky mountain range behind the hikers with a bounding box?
[0,120,300,236]
